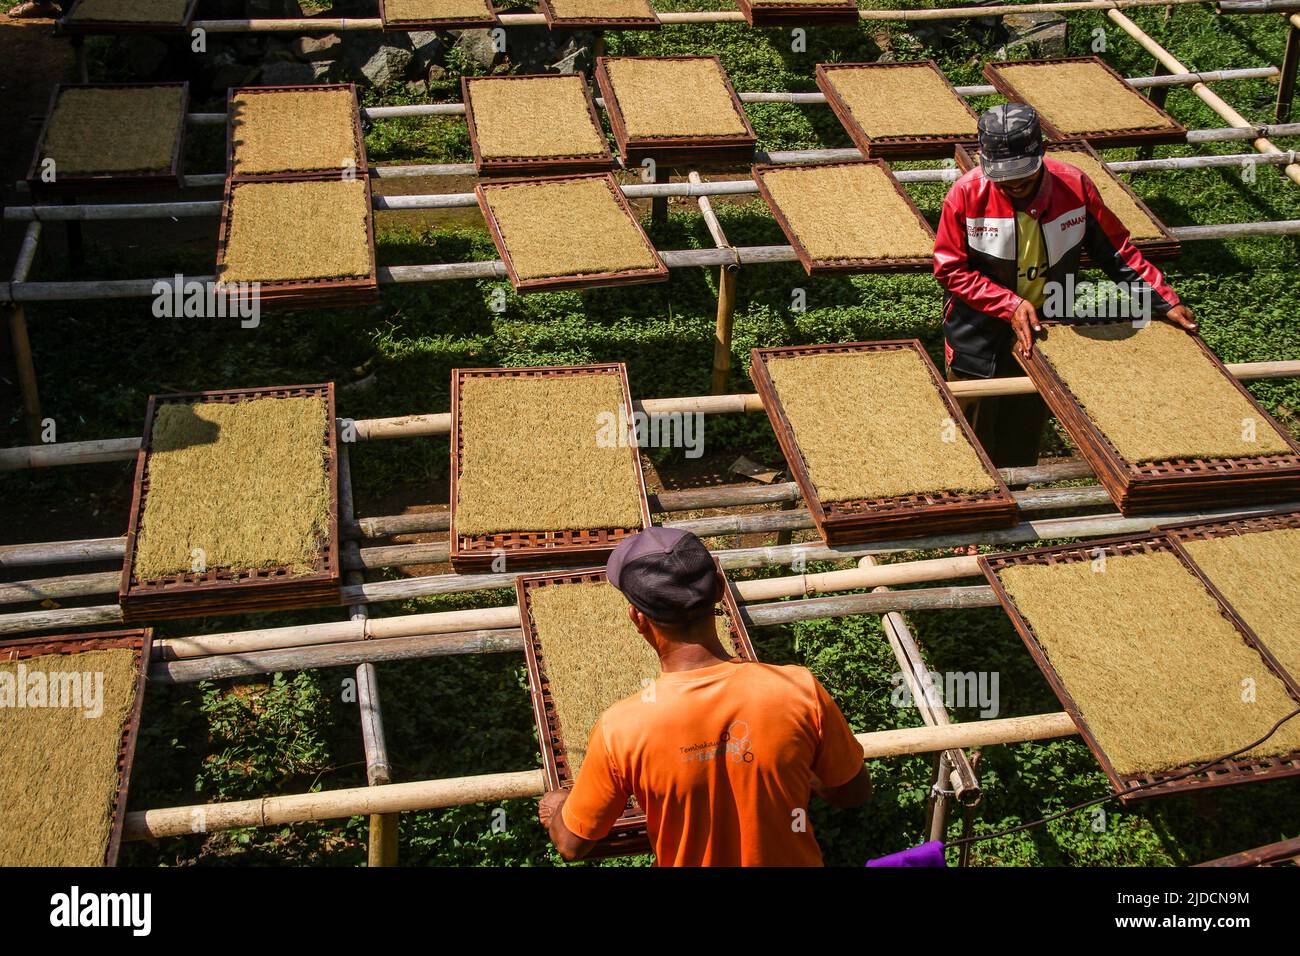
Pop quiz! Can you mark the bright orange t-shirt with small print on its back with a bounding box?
[563,659,863,866]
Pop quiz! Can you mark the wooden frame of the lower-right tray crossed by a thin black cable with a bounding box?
[979,535,1300,803]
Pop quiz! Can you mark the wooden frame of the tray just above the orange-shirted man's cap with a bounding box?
[450,362,651,574]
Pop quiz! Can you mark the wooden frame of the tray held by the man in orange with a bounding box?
[515,559,758,860]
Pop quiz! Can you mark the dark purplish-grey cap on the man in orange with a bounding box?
[605,527,718,624]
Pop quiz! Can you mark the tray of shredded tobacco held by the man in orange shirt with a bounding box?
[515,570,758,858]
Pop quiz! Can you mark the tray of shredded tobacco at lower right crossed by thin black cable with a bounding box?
[979,533,1300,800]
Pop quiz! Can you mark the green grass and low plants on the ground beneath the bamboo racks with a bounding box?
[10,0,1300,865]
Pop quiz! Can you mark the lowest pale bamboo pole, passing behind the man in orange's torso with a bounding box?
[122,713,1078,840]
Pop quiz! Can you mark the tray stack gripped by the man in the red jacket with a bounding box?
[1017,321,1300,515]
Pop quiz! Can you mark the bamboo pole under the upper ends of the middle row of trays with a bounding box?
[0,359,1300,473]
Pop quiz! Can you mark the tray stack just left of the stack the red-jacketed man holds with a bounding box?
[749,339,1018,546]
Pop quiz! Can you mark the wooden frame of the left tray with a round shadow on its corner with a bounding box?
[117,382,341,622]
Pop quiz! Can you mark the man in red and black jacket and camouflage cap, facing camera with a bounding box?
[935,103,1196,467]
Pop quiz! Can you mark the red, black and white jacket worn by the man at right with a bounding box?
[935,159,1179,378]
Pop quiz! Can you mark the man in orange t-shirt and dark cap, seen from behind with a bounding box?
[540,528,871,866]
